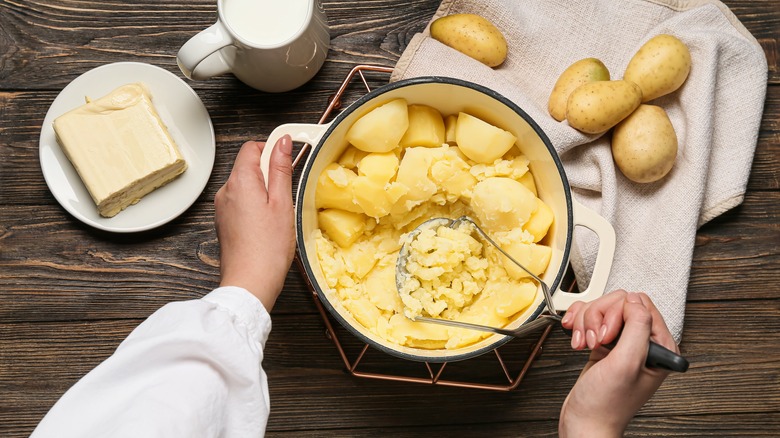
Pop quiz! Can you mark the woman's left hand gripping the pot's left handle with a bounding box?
[214,136,295,312]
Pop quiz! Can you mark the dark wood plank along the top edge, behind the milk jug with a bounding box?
[0,0,438,92]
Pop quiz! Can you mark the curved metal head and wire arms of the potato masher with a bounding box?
[395,216,561,337]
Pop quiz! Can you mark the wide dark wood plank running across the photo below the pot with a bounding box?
[0,299,780,436]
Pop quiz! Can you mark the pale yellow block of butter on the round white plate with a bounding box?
[54,83,187,217]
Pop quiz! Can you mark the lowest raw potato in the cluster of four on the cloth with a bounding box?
[612,105,677,183]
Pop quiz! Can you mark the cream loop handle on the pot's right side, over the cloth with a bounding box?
[553,199,615,311]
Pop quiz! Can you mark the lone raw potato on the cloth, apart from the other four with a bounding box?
[431,14,507,67]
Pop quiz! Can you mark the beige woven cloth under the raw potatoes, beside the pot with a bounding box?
[391,0,767,341]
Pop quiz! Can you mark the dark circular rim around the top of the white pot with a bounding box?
[295,76,574,363]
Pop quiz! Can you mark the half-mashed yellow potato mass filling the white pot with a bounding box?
[314,101,553,349]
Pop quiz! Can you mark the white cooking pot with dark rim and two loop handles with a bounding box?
[261,77,615,362]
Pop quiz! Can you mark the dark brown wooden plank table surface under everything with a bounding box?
[0,0,780,437]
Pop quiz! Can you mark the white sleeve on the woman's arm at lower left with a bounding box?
[32,287,271,438]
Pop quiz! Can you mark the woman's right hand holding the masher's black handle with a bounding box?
[559,290,679,437]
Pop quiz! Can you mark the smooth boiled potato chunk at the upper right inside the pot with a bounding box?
[455,113,517,164]
